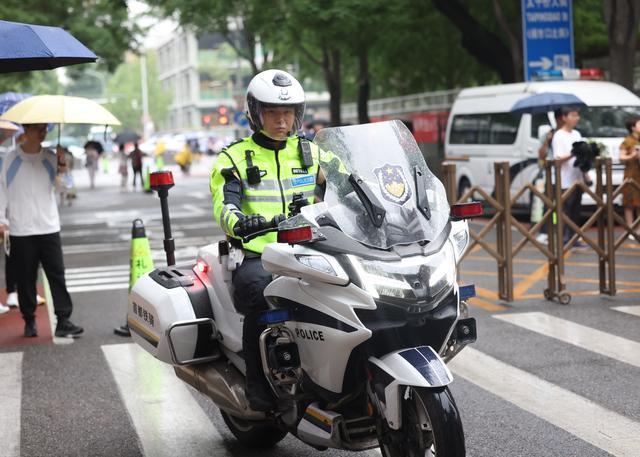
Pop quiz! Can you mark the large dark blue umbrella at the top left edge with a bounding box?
[0,21,98,73]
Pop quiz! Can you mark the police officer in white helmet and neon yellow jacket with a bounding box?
[210,70,324,411]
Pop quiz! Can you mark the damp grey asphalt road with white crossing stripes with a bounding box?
[0,158,640,457]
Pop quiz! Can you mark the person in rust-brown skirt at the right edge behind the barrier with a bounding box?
[620,116,640,241]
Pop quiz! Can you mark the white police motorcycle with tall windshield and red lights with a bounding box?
[128,121,482,457]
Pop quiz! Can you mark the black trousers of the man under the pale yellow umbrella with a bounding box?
[11,232,73,322]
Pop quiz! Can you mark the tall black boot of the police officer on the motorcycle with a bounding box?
[242,312,276,411]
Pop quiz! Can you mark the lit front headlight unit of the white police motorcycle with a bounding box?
[348,243,456,300]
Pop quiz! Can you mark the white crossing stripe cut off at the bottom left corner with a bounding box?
[0,352,22,457]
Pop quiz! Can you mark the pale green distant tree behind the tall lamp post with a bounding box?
[106,52,171,133]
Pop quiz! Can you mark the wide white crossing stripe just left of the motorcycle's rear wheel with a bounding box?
[102,344,228,457]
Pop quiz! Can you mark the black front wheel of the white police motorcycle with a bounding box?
[380,387,466,457]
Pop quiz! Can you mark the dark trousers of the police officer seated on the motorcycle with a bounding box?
[232,257,273,383]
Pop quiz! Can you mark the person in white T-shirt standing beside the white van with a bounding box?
[551,107,586,248]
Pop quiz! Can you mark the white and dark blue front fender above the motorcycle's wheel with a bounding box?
[369,346,453,430]
